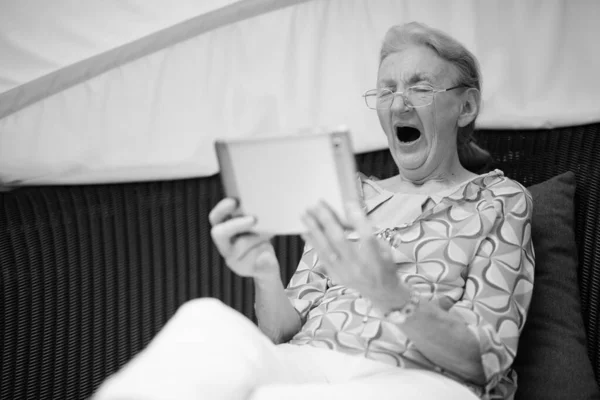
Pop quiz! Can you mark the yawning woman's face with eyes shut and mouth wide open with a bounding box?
[377,46,461,182]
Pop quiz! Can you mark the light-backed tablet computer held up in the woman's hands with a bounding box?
[215,131,359,235]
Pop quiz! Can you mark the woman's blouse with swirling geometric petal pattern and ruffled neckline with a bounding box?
[286,170,535,399]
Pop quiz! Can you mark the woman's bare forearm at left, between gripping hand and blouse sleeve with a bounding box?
[254,275,302,344]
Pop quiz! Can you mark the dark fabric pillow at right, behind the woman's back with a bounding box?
[514,172,600,400]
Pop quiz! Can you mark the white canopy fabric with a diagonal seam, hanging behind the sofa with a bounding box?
[0,0,600,186]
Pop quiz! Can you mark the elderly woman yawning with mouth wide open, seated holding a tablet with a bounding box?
[97,23,534,399]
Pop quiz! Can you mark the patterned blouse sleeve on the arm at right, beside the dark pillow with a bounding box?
[450,182,535,393]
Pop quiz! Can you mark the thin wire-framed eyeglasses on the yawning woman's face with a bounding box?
[363,85,465,110]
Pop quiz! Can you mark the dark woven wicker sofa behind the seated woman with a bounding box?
[0,124,600,399]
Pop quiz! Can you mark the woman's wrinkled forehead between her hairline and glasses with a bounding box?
[377,47,458,87]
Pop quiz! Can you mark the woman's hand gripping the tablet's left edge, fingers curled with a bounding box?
[208,198,280,280]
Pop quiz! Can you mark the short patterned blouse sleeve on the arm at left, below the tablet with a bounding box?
[285,245,329,323]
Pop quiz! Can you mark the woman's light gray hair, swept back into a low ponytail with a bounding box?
[379,22,492,173]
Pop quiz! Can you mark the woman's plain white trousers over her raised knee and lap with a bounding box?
[93,298,477,400]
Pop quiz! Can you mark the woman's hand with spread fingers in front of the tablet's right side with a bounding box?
[302,202,410,312]
